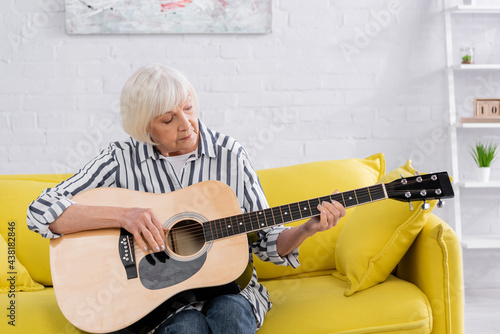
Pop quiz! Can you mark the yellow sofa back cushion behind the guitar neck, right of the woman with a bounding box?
[255,153,385,279]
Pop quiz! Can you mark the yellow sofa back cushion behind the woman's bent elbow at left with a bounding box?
[0,174,70,286]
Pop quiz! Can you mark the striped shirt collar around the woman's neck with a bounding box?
[135,120,217,163]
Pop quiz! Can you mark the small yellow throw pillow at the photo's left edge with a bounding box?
[0,235,44,293]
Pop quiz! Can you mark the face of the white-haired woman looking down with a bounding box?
[149,97,200,156]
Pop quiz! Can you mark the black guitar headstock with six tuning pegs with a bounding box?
[385,172,455,207]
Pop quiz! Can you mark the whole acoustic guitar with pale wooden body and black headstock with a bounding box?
[50,172,454,333]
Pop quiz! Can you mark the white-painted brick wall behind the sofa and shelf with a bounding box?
[0,0,500,287]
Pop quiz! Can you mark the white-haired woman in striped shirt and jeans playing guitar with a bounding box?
[27,64,345,334]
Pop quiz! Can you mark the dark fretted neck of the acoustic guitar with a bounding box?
[203,184,388,241]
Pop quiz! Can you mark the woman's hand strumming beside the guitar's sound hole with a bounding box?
[120,208,167,253]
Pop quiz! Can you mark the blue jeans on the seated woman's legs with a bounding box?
[155,294,256,334]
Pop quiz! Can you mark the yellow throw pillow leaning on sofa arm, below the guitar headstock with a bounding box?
[334,161,437,296]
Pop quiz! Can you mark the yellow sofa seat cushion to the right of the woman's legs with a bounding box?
[259,273,432,334]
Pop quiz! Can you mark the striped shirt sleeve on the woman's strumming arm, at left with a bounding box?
[26,145,116,238]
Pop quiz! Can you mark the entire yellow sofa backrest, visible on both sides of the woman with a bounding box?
[0,154,385,286]
